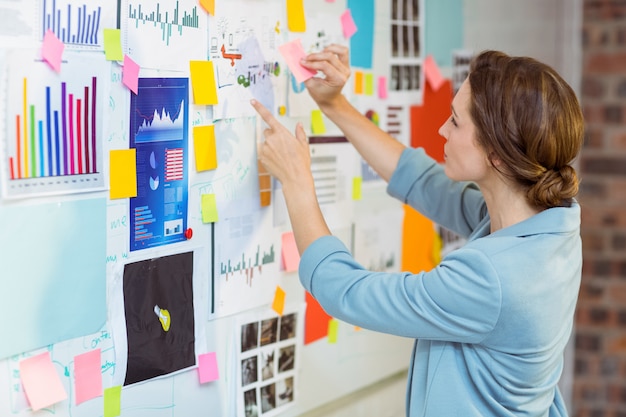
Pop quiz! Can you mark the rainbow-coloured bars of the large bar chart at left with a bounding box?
[8,77,98,180]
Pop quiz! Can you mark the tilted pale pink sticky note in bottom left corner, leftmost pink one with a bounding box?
[19,352,67,411]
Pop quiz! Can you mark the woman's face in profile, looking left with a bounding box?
[439,80,492,184]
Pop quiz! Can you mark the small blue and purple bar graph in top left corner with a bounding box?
[41,0,102,46]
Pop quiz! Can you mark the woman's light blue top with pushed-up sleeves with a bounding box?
[299,148,582,417]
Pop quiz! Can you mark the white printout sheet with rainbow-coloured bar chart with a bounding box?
[2,51,106,198]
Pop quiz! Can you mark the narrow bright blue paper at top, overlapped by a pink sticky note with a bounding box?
[348,0,375,69]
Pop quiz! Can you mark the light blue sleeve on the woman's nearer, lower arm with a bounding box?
[299,236,502,343]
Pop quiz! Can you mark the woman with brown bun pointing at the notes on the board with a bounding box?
[252,45,583,417]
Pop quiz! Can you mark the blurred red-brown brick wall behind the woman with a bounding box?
[573,0,626,417]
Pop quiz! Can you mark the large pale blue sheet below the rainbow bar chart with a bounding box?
[0,198,107,358]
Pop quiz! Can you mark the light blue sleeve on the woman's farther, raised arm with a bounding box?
[387,148,487,237]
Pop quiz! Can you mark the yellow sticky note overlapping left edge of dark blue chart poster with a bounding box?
[109,148,137,199]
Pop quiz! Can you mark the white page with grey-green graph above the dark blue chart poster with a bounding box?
[120,0,208,71]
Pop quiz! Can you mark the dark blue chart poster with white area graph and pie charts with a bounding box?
[130,78,189,251]
